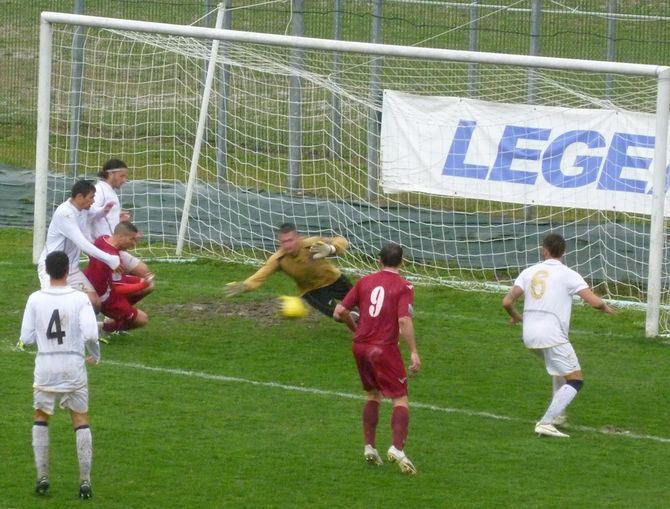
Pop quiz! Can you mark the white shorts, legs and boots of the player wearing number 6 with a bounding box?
[535,343,584,438]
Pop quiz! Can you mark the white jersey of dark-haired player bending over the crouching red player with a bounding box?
[38,200,120,274]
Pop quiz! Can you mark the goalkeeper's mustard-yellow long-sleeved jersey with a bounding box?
[244,237,349,295]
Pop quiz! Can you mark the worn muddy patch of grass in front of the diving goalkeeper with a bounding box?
[152,299,321,326]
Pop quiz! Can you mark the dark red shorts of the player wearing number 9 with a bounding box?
[351,343,407,398]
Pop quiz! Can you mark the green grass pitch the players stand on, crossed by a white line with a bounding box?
[0,230,670,509]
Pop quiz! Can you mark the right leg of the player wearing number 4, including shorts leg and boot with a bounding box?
[61,388,93,499]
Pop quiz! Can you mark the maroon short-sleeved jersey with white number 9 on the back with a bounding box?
[342,269,414,345]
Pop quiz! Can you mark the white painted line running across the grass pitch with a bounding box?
[103,360,670,444]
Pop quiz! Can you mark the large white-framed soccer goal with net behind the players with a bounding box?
[34,9,670,335]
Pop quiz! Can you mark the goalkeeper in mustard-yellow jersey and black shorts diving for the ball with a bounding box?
[225,223,351,326]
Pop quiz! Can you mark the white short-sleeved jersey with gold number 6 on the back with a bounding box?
[514,259,588,348]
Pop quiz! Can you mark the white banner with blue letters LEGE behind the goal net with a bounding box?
[381,90,670,214]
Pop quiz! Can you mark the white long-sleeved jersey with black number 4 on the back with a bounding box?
[21,286,100,392]
